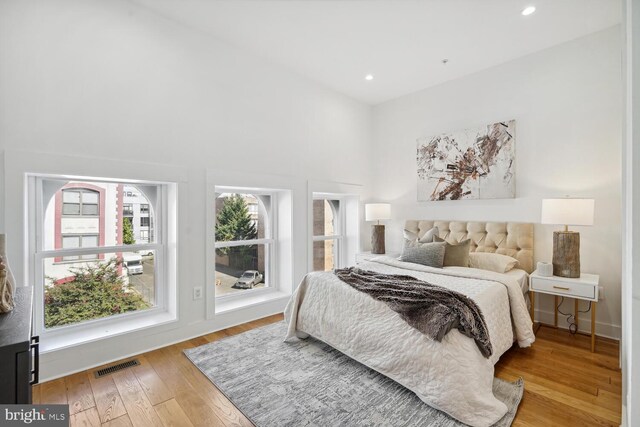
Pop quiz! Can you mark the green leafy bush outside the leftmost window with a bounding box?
[44,258,150,328]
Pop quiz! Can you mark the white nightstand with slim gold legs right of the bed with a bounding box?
[529,271,600,353]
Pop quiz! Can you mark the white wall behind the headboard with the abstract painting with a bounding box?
[372,27,622,337]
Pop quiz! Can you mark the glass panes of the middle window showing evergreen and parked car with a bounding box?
[215,189,275,297]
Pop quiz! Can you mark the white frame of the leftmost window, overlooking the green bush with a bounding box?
[27,174,173,337]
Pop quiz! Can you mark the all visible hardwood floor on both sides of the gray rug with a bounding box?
[33,315,622,427]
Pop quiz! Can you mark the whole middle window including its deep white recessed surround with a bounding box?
[204,168,296,319]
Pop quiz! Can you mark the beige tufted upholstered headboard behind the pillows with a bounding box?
[404,220,534,273]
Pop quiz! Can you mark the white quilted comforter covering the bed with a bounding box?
[285,257,535,426]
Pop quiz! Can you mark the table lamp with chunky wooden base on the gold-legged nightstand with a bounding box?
[540,198,595,278]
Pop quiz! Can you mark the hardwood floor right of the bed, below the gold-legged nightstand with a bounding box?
[496,326,622,426]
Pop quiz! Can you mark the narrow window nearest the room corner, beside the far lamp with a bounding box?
[312,197,343,271]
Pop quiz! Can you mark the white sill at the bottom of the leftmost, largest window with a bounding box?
[40,311,177,353]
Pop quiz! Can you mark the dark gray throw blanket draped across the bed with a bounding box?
[335,267,493,358]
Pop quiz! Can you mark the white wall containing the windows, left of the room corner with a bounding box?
[0,0,371,379]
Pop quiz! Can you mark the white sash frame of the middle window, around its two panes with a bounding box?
[213,189,278,302]
